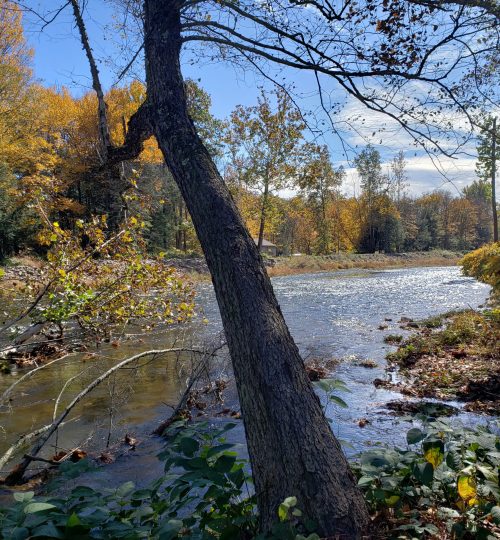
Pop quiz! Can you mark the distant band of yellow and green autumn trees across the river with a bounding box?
[0,6,492,258]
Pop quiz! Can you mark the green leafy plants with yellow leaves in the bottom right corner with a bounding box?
[356,420,500,540]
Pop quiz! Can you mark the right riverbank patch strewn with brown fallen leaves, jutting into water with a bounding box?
[375,310,500,415]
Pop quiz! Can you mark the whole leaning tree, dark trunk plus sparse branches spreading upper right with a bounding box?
[16,0,498,538]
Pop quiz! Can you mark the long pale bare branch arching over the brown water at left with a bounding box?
[0,348,206,485]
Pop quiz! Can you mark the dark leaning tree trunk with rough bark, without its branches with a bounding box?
[145,0,368,539]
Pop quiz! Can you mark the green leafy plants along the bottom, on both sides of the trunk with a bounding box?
[0,421,500,540]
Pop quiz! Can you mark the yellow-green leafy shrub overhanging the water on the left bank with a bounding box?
[0,217,194,363]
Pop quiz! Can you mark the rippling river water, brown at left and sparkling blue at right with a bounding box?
[0,267,489,490]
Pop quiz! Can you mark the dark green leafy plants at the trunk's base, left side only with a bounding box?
[0,422,319,540]
